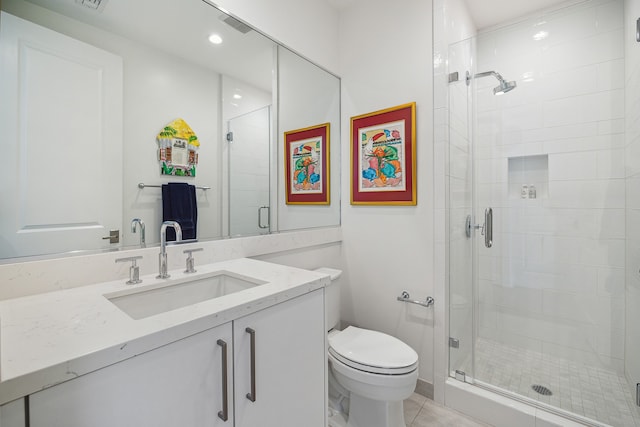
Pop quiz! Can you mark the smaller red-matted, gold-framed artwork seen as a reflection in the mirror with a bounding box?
[284,123,331,205]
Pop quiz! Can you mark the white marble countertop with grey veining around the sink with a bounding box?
[0,258,330,404]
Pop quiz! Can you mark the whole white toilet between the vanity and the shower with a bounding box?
[316,268,418,427]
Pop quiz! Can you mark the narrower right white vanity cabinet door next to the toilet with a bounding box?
[233,289,327,427]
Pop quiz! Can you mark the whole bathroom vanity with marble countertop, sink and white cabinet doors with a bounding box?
[0,259,329,427]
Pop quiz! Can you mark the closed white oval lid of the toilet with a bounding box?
[329,326,418,375]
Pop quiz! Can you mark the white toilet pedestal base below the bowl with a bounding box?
[346,394,406,427]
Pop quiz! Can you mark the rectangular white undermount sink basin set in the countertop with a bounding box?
[104,271,267,319]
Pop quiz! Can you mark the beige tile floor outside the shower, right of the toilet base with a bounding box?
[404,393,488,427]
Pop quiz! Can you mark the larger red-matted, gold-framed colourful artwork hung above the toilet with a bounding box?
[351,102,417,206]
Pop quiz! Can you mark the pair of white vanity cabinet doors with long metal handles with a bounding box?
[25,289,326,427]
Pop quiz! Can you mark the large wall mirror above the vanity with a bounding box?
[0,0,340,262]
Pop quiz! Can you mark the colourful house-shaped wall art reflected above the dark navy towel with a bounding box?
[156,119,200,176]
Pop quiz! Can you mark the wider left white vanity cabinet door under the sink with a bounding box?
[30,324,233,427]
